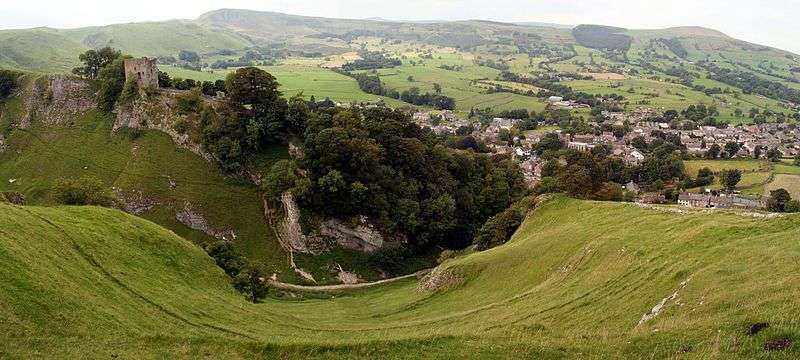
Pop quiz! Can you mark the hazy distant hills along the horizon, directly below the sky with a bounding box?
[0,9,789,72]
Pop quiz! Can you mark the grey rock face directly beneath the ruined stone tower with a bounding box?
[114,89,212,161]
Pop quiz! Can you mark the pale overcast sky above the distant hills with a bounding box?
[0,0,800,53]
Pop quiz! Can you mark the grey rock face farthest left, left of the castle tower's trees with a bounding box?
[18,75,97,129]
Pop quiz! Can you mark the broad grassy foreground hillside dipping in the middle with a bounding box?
[0,198,800,359]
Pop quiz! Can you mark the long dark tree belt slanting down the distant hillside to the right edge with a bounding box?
[700,62,800,104]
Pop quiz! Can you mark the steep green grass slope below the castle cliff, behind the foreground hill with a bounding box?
[0,105,294,280]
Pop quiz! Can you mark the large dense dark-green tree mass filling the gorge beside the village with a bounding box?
[266,107,525,250]
